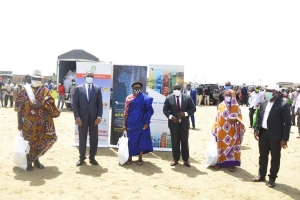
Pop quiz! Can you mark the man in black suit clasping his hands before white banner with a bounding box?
[163,83,196,167]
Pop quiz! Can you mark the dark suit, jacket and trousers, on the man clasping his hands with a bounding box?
[163,94,196,161]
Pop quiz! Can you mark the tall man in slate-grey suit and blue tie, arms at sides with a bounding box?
[73,71,103,166]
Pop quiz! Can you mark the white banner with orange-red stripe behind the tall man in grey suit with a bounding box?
[74,62,111,147]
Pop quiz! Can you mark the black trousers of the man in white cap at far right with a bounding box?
[258,128,281,179]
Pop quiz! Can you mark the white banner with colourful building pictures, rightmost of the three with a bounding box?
[147,65,184,151]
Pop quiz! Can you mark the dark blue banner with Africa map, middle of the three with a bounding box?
[110,65,147,146]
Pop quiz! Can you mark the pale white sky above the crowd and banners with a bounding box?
[0,0,300,84]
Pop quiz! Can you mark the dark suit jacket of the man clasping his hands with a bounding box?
[163,94,196,131]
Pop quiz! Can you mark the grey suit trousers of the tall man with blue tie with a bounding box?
[78,116,98,160]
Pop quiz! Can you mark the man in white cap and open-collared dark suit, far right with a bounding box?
[252,84,291,187]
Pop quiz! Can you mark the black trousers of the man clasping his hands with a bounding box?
[170,123,190,161]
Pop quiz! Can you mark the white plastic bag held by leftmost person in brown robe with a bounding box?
[13,132,30,170]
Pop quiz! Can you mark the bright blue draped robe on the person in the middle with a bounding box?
[124,93,154,156]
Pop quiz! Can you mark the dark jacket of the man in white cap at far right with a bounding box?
[255,97,291,142]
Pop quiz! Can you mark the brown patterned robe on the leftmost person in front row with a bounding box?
[15,86,60,164]
